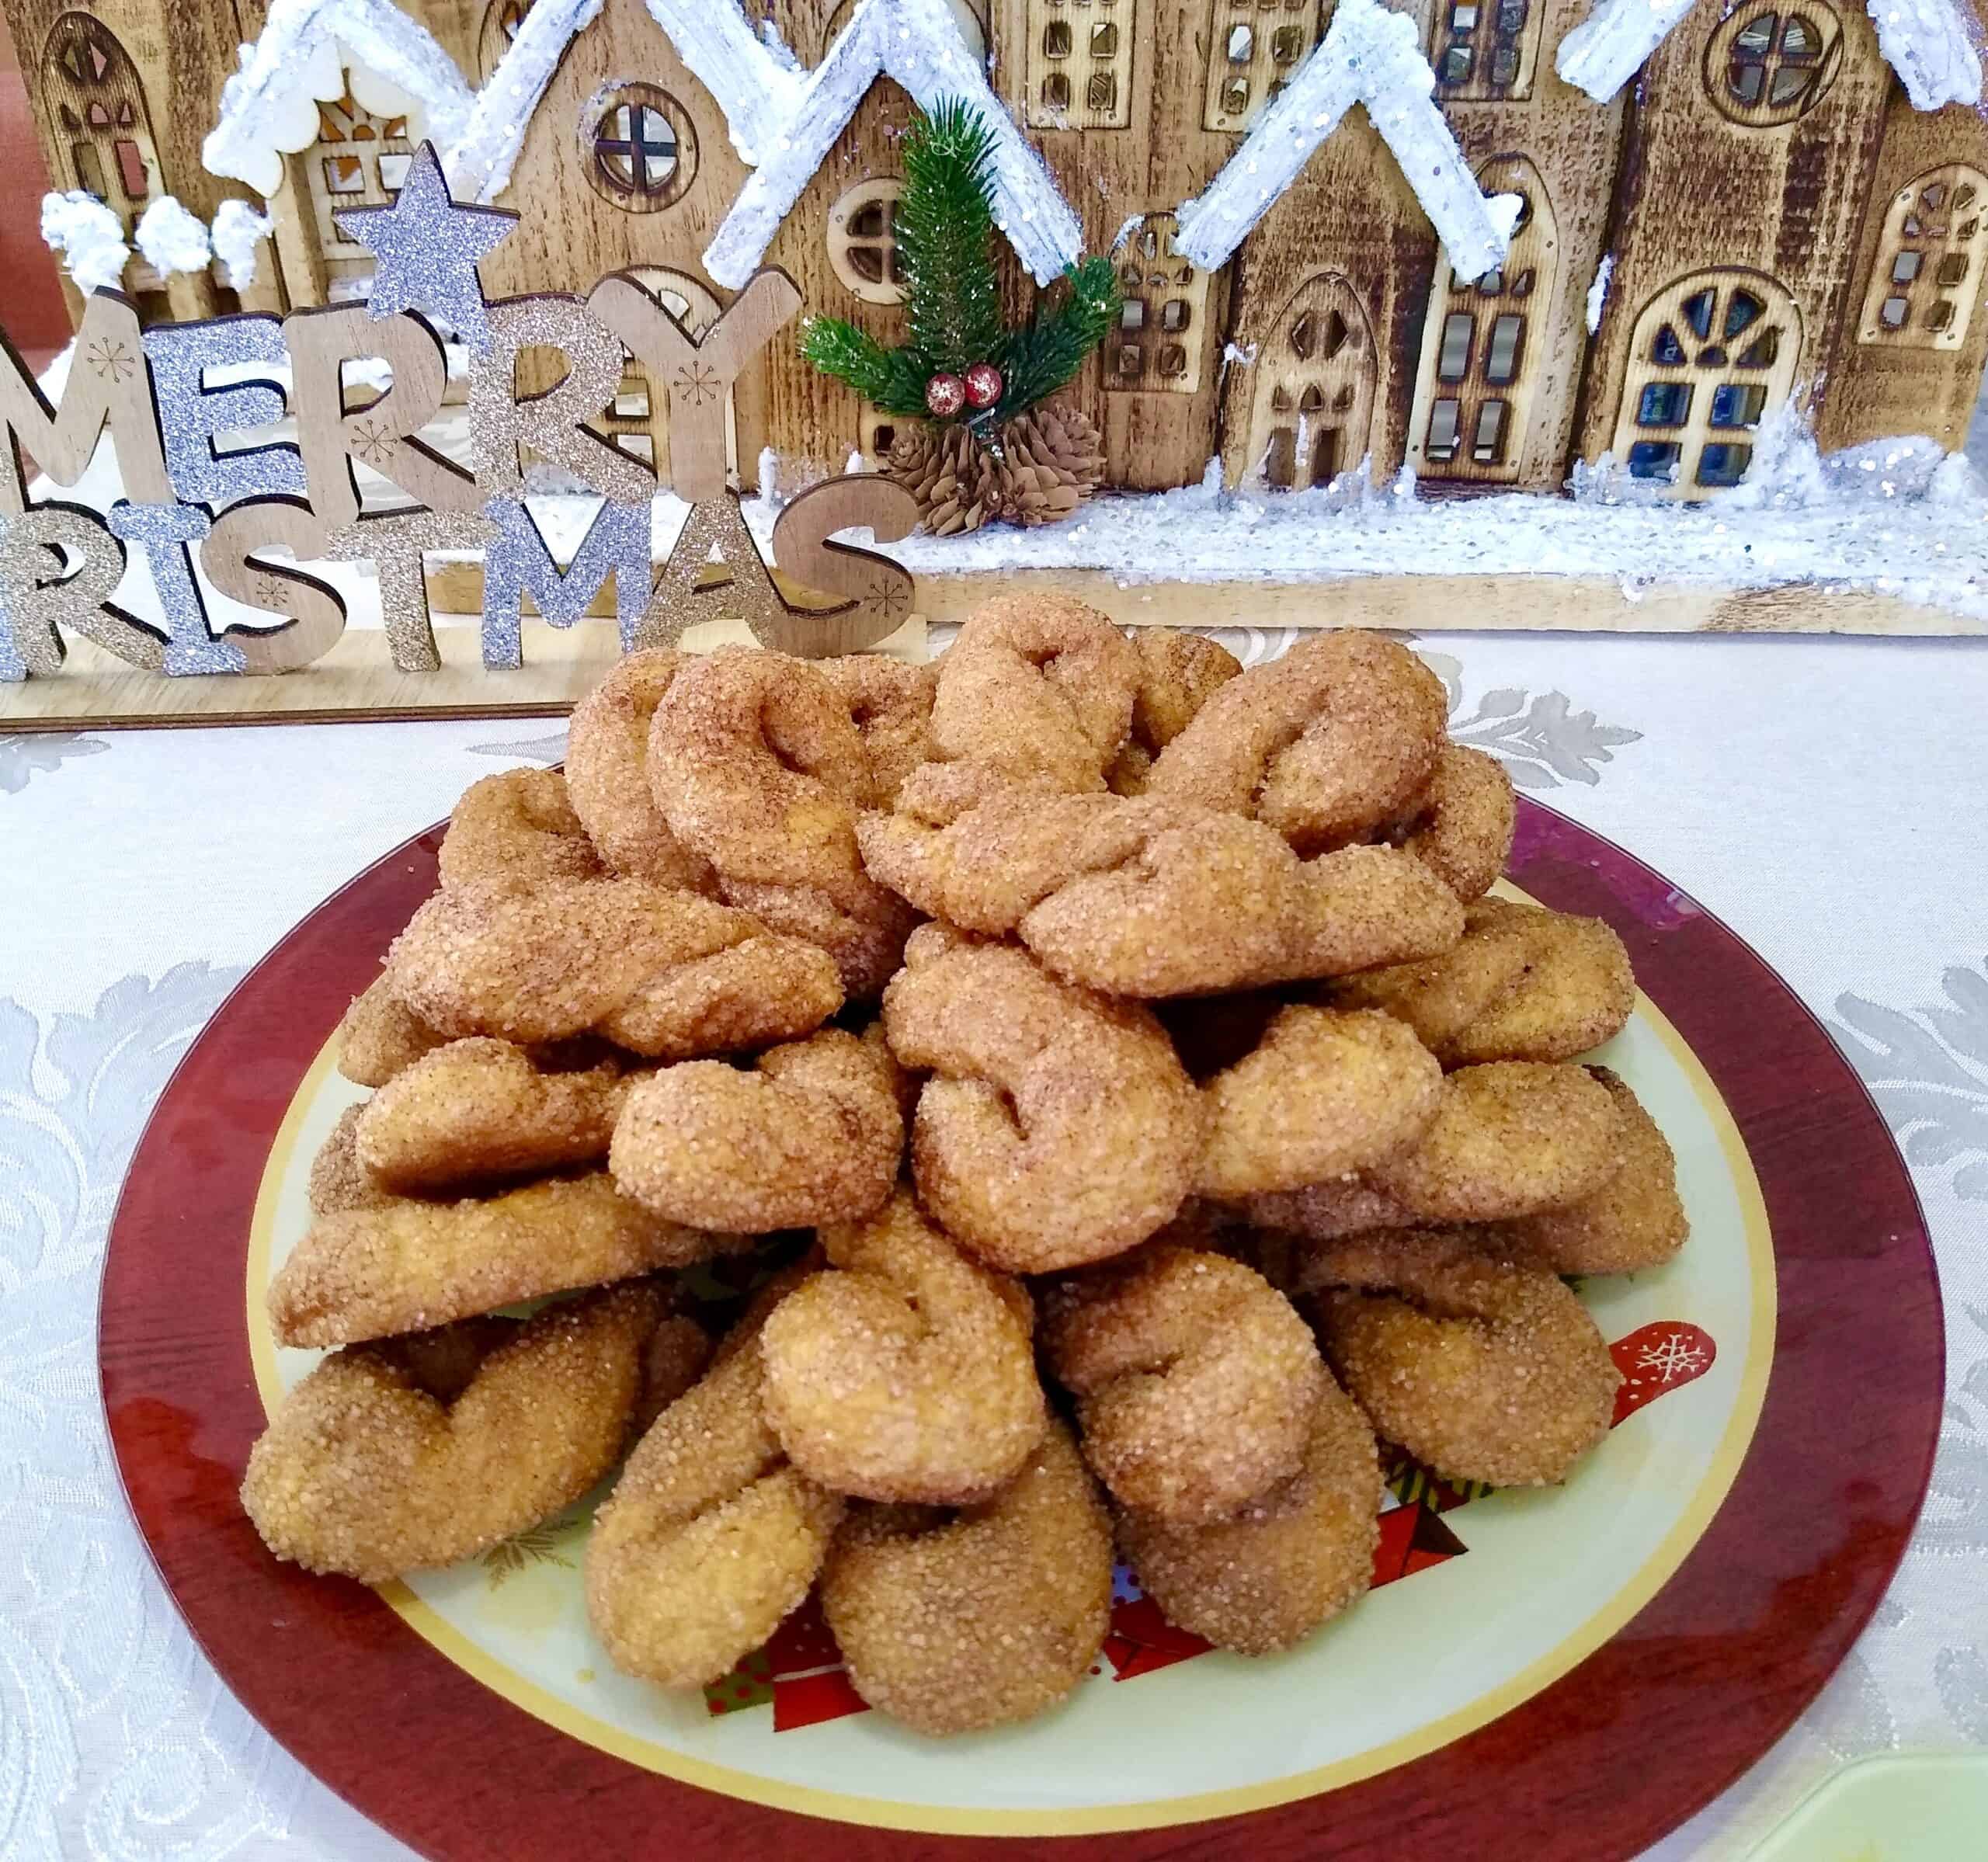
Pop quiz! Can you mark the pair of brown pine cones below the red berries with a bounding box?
[888,397,1105,537]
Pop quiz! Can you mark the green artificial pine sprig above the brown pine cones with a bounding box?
[801,97,1119,435]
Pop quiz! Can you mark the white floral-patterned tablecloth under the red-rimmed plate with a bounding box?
[0,630,1988,1862]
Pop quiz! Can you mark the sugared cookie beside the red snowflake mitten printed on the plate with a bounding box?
[1300,1230,1622,1486]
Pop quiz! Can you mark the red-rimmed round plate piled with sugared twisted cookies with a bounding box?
[99,594,1942,1862]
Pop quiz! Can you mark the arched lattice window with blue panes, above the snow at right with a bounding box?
[1614,270,1801,499]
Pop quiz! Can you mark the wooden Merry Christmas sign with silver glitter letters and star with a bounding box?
[0,145,916,682]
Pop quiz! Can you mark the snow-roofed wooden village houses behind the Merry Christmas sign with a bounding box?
[0,0,1988,719]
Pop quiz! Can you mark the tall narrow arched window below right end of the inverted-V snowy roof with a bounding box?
[1407,155,1561,485]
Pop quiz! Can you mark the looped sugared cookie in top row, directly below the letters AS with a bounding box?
[648,650,912,999]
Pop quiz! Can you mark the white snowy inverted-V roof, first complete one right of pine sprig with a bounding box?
[1173,0,1510,278]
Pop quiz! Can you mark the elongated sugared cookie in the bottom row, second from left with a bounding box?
[586,1301,843,1687]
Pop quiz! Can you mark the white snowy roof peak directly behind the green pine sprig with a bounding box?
[704,0,1083,290]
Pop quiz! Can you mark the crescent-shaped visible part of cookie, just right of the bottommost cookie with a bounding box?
[1117,1375,1382,1655]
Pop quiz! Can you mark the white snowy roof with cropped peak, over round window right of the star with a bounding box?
[443,0,801,200]
